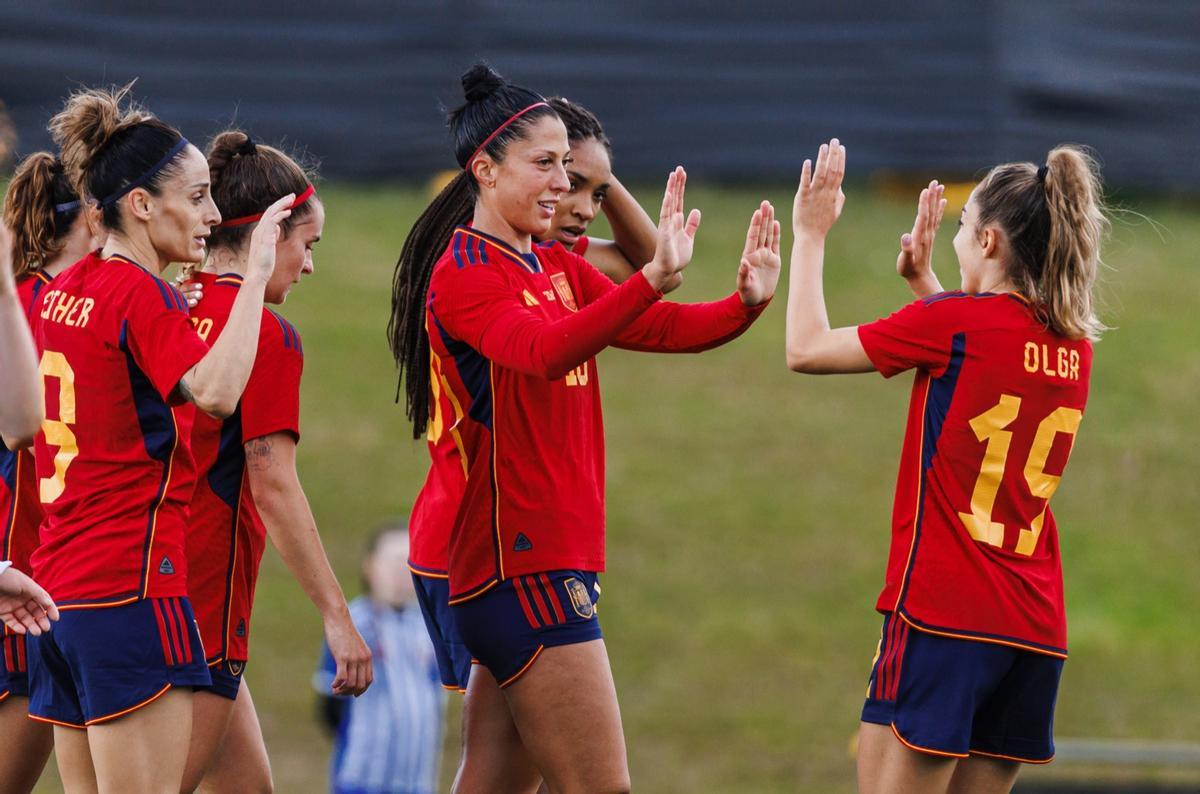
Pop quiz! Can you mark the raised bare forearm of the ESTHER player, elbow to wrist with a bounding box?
[180,278,266,417]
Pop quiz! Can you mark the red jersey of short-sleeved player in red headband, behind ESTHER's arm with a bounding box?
[187,273,304,664]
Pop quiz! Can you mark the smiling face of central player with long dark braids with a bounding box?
[474,116,571,239]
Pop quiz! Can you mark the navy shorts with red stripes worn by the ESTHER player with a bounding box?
[28,596,211,728]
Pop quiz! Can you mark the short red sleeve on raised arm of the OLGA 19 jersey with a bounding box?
[858,293,955,378]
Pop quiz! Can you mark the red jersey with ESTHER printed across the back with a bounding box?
[32,254,208,608]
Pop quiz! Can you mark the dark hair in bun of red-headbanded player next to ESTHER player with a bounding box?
[208,130,317,249]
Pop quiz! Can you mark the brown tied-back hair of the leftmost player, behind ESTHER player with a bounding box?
[4,151,80,278]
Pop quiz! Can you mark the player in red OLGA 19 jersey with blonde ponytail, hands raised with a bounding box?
[787,139,1105,794]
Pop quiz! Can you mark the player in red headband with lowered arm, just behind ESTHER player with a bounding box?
[184,131,372,792]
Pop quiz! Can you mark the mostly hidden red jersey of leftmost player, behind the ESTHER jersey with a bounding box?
[0,270,50,582]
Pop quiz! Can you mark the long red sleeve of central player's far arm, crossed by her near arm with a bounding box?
[570,250,770,353]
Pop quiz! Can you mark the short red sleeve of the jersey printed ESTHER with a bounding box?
[125,276,209,404]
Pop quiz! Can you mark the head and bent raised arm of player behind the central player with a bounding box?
[546,96,658,283]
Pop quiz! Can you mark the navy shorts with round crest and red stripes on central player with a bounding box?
[454,571,602,688]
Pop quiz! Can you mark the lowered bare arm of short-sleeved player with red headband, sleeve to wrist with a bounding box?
[246,438,349,621]
